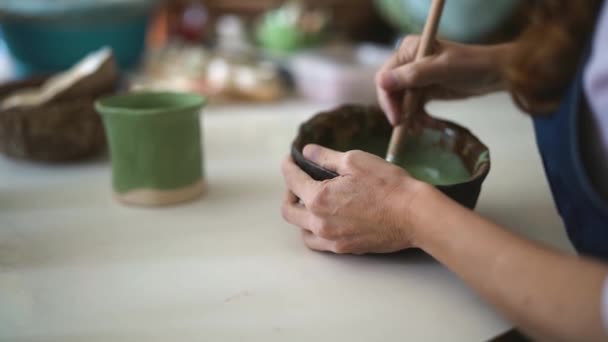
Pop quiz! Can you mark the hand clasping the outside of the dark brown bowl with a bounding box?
[282,145,426,254]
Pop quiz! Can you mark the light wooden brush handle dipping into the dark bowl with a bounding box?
[386,0,445,162]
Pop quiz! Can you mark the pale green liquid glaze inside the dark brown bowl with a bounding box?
[329,129,471,185]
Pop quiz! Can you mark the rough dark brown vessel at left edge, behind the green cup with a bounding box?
[0,56,118,162]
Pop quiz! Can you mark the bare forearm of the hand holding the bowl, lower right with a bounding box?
[411,188,607,340]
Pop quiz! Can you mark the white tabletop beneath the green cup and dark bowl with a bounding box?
[0,94,570,342]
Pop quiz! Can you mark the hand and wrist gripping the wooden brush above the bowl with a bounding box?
[376,35,513,125]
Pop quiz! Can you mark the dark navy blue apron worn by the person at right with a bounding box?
[534,56,608,261]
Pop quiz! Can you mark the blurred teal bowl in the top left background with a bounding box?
[0,0,157,76]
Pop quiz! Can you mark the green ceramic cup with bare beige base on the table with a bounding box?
[95,92,205,206]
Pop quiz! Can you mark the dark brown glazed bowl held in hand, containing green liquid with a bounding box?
[291,105,490,209]
